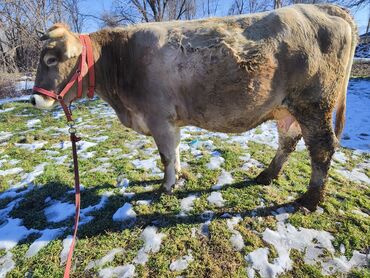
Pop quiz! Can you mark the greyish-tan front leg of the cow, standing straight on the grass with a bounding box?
[152,123,180,193]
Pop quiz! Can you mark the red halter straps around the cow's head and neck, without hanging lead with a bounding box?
[33,35,95,122]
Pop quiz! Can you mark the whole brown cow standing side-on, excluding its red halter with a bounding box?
[31,5,357,210]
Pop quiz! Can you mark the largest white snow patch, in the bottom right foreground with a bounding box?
[245,208,367,277]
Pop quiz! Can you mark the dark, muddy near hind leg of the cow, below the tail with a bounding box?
[297,112,338,211]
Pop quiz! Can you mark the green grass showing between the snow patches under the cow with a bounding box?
[0,101,370,277]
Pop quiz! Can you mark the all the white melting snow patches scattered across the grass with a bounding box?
[0,77,370,277]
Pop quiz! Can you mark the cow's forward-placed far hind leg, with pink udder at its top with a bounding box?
[256,115,302,185]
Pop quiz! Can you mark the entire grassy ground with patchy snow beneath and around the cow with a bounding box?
[0,80,370,277]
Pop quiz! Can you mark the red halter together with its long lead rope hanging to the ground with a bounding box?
[33,35,95,278]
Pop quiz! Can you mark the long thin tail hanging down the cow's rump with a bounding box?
[335,8,358,140]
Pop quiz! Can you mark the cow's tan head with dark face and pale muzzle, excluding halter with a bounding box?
[30,23,82,109]
